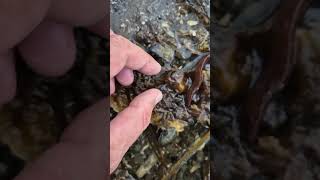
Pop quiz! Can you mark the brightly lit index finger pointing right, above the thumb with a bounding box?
[110,31,161,78]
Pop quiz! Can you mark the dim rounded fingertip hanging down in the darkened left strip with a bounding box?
[18,21,76,77]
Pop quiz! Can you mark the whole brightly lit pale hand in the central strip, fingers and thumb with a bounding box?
[110,31,162,174]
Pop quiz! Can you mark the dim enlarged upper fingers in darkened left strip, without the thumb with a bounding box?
[0,0,109,106]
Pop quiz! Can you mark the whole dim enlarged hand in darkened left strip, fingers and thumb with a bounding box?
[0,0,109,180]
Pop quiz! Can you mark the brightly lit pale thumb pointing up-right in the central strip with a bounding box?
[110,89,162,173]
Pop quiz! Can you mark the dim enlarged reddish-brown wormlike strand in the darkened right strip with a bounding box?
[241,0,312,142]
